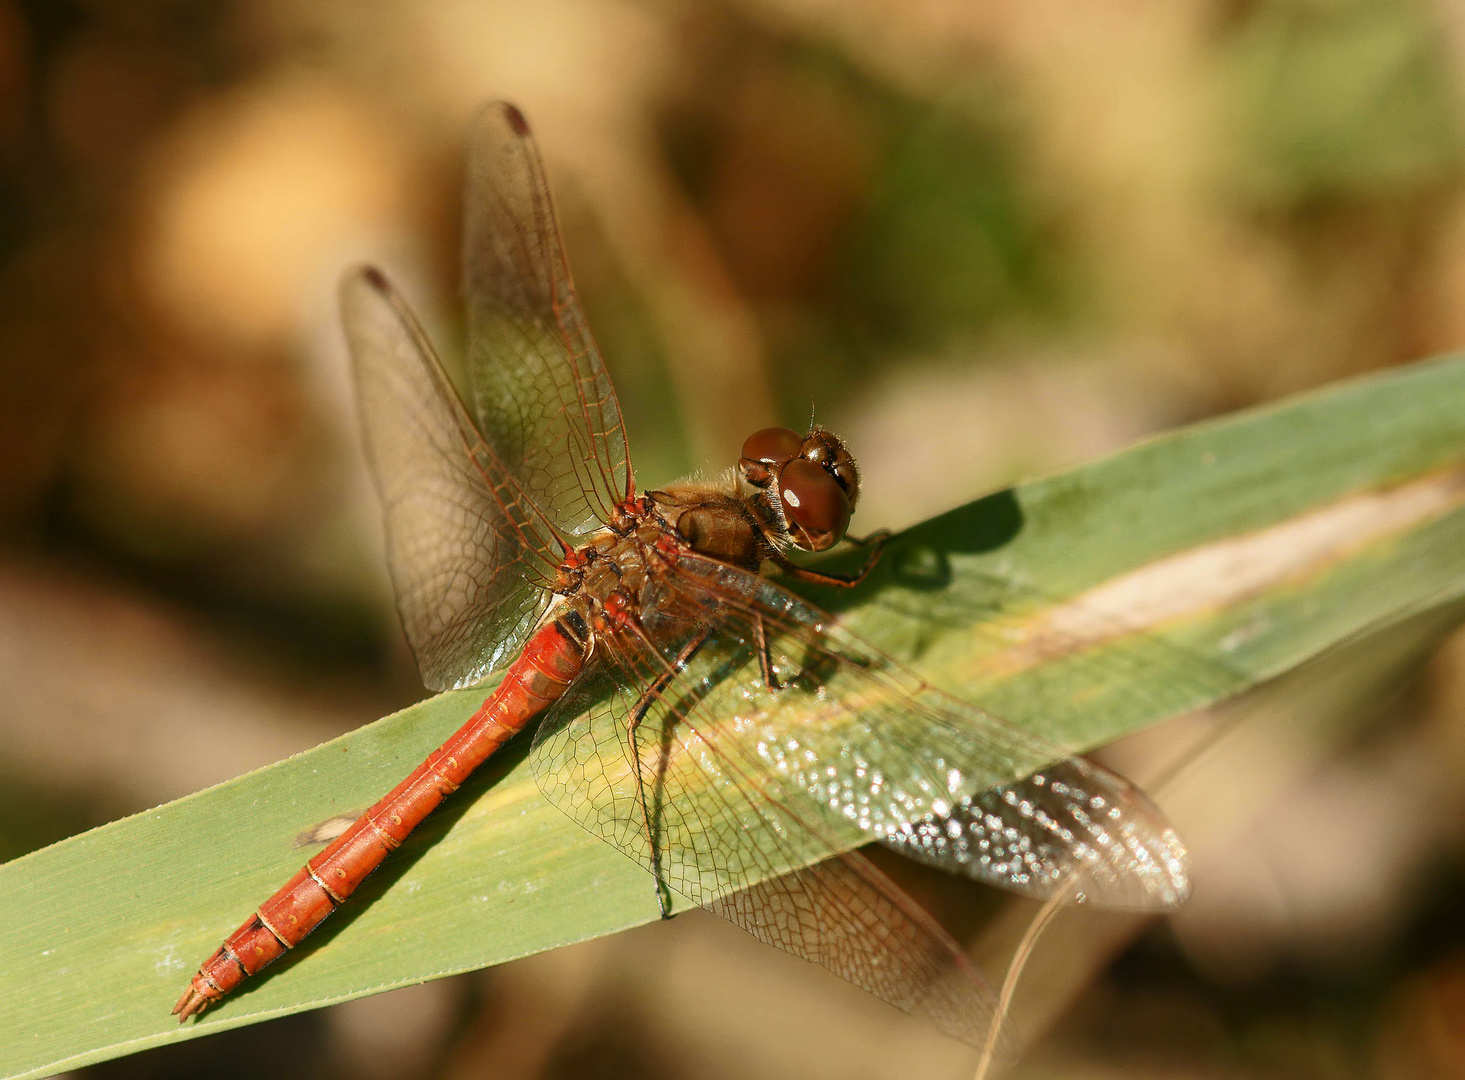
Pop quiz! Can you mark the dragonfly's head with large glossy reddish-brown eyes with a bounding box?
[738,428,860,551]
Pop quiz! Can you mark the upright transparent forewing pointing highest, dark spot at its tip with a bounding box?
[463,103,631,536]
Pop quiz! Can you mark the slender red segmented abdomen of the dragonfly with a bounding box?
[173,621,585,1021]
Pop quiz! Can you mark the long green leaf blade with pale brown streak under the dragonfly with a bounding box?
[0,359,1465,1076]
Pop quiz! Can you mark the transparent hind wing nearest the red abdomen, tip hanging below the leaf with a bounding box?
[532,637,993,1045]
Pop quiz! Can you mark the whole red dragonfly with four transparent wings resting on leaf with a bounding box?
[173,103,1190,1043]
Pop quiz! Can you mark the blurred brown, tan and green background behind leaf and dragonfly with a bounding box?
[0,0,1465,1080]
